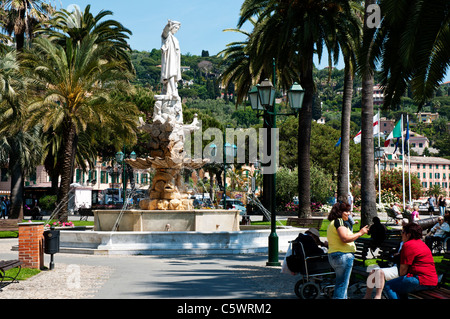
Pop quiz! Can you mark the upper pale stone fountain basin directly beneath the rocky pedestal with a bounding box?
[94,209,240,232]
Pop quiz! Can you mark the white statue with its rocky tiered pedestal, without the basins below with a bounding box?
[127,20,207,210]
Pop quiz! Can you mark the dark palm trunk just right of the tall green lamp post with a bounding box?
[297,42,314,218]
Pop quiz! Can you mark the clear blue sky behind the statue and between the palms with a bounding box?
[52,0,450,82]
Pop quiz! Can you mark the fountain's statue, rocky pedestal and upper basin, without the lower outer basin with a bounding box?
[94,20,243,231]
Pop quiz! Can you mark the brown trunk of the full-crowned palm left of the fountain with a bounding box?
[57,121,76,222]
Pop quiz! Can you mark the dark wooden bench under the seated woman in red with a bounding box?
[409,252,450,299]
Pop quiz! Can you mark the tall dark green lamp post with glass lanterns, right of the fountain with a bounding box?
[248,75,305,266]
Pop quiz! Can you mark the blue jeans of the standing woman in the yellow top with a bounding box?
[328,252,355,299]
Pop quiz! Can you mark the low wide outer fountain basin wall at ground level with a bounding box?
[60,227,300,255]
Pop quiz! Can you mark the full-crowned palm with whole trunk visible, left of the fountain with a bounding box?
[23,35,138,219]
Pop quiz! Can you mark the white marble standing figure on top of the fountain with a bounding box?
[161,20,181,100]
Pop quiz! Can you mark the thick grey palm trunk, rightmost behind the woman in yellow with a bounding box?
[361,0,377,227]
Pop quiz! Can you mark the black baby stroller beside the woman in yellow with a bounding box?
[286,240,335,299]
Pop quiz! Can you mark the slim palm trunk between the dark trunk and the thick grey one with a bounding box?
[337,61,353,202]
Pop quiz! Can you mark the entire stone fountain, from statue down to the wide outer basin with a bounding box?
[60,20,299,255]
